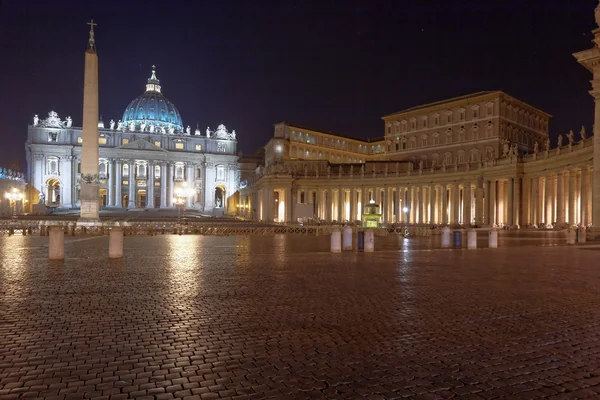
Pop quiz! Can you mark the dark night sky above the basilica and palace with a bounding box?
[0,0,597,170]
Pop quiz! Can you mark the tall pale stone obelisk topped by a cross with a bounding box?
[80,20,100,222]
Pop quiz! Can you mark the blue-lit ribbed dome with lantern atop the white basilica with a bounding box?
[122,66,183,133]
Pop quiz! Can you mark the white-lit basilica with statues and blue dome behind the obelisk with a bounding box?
[25,69,239,215]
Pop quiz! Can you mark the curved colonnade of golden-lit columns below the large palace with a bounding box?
[245,165,592,227]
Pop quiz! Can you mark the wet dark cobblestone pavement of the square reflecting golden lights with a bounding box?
[0,236,600,400]
